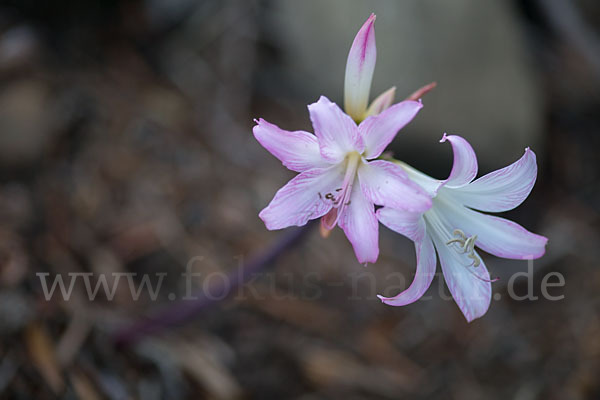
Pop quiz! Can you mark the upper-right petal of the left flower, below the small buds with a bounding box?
[358,100,423,160]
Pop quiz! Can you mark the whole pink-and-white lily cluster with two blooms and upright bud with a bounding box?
[253,15,547,321]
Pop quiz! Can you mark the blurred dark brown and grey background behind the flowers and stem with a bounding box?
[0,0,600,400]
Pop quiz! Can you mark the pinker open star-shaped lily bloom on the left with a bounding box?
[253,96,431,263]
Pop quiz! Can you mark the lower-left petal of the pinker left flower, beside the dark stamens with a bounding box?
[258,166,344,230]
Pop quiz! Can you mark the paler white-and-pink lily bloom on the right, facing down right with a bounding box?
[377,134,548,322]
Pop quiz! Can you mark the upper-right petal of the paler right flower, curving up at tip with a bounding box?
[452,148,537,212]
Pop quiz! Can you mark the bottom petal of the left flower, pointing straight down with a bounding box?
[338,185,379,264]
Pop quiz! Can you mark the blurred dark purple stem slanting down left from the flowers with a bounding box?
[113,221,316,347]
